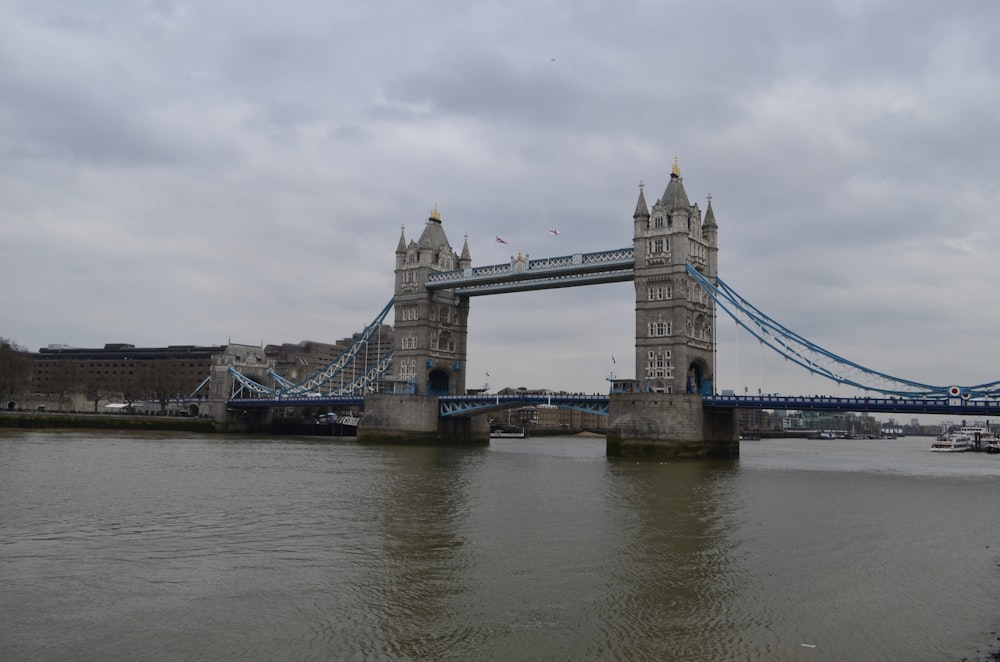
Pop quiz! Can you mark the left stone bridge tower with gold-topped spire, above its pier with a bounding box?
[393,206,472,396]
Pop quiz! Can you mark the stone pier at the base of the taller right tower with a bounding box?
[607,393,740,459]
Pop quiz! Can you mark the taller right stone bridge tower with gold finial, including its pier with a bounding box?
[607,158,739,457]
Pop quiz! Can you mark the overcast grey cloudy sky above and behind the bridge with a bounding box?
[0,0,1000,400]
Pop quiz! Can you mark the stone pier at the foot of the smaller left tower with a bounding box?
[358,393,490,446]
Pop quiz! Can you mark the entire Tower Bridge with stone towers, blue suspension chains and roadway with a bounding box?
[229,160,1000,457]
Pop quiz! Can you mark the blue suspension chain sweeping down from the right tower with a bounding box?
[687,264,1000,400]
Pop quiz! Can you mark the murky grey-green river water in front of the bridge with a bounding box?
[0,431,1000,662]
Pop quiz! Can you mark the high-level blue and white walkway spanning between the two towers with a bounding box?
[427,246,635,296]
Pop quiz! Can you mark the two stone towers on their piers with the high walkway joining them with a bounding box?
[358,161,739,456]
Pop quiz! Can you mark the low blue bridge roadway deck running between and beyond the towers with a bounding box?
[227,393,1000,418]
